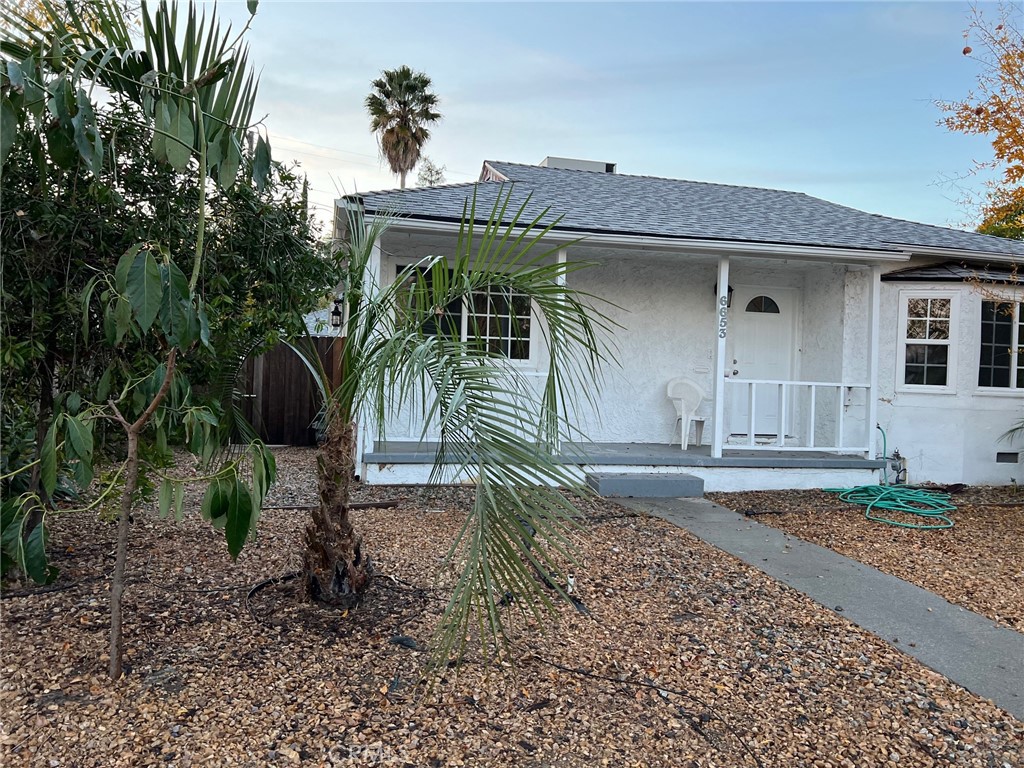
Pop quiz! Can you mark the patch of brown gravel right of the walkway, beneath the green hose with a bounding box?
[708,486,1024,631]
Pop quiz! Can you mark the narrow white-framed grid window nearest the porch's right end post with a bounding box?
[897,291,958,391]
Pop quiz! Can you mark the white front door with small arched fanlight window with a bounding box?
[725,286,797,436]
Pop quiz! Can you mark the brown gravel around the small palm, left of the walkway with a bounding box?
[0,450,1024,768]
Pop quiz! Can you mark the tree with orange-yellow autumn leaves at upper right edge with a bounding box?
[936,3,1024,240]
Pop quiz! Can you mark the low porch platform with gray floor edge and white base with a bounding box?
[361,440,884,496]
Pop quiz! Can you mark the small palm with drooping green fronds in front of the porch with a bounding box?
[300,190,611,660]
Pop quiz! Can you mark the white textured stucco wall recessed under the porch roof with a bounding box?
[372,231,867,454]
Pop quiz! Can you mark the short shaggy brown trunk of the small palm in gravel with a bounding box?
[303,417,373,608]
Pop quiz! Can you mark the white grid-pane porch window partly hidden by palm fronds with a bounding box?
[398,267,532,360]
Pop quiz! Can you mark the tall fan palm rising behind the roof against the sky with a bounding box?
[366,66,441,189]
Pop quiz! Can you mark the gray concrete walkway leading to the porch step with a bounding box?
[615,499,1024,721]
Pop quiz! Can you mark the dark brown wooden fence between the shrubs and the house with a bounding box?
[243,337,343,445]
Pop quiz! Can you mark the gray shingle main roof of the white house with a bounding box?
[354,161,1024,256]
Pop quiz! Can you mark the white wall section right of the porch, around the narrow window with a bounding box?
[878,274,1024,484]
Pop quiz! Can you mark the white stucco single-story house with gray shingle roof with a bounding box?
[336,158,1024,495]
